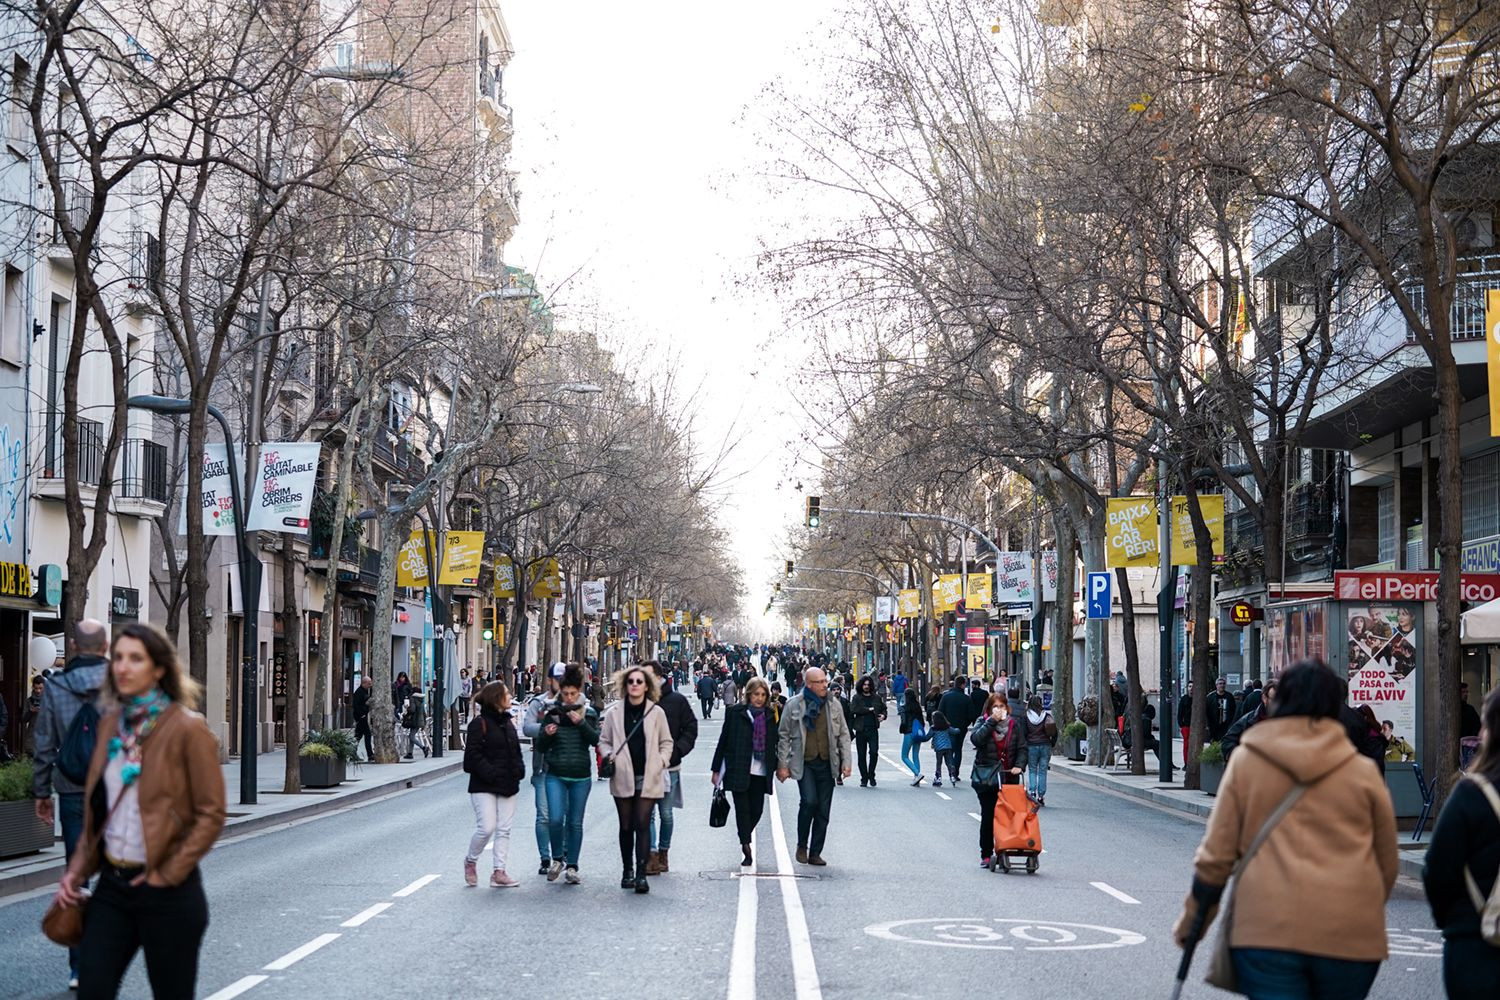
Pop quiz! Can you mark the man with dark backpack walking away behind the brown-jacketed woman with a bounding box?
[32,618,112,990]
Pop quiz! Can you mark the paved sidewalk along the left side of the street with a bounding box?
[0,750,464,897]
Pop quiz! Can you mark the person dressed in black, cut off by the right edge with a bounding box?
[1422,688,1500,1000]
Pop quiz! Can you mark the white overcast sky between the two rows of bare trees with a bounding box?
[503,0,830,618]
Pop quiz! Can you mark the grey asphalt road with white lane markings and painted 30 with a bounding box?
[0,715,1442,1000]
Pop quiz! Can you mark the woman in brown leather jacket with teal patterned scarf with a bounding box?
[56,622,225,1000]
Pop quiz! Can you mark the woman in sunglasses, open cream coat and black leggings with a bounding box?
[599,664,674,894]
